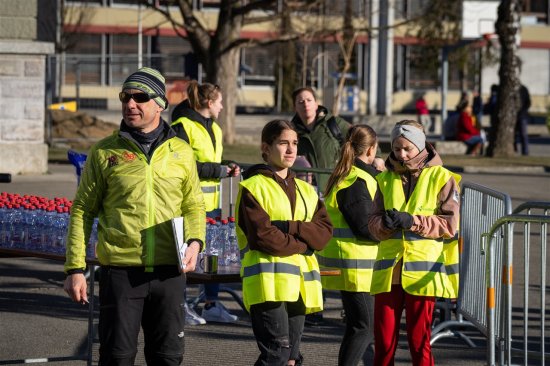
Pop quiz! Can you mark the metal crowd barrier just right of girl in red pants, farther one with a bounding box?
[430,182,512,348]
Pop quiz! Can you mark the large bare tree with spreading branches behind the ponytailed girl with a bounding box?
[147,0,320,144]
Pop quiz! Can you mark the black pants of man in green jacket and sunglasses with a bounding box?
[99,266,185,366]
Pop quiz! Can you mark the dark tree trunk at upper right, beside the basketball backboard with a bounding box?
[487,0,520,157]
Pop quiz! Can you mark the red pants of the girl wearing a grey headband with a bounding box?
[374,285,435,366]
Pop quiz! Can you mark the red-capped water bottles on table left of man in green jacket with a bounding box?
[0,192,97,258]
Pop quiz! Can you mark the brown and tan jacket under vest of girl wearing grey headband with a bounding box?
[368,144,460,283]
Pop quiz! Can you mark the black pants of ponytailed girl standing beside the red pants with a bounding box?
[338,291,374,366]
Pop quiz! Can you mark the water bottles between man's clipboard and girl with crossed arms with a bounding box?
[205,217,241,273]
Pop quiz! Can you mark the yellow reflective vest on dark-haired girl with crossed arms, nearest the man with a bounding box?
[236,174,323,313]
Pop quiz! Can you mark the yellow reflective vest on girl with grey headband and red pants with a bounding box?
[371,166,460,298]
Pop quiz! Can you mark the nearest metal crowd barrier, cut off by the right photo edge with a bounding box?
[483,202,550,366]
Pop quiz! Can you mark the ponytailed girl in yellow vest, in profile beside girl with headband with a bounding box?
[317,125,379,366]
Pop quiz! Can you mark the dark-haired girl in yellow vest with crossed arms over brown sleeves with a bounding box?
[237,120,332,366]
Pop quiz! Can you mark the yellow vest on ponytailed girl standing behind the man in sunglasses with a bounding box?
[172,117,223,212]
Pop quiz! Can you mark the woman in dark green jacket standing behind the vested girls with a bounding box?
[292,87,350,192]
